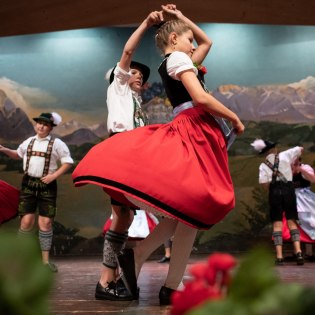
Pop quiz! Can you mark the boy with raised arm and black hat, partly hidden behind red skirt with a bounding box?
[95,11,162,301]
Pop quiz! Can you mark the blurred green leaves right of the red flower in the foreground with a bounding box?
[185,247,315,315]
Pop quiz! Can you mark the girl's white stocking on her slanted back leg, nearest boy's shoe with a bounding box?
[133,218,178,277]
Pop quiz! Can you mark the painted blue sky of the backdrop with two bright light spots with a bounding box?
[0,23,315,124]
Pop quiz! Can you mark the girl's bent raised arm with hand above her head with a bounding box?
[162,4,212,65]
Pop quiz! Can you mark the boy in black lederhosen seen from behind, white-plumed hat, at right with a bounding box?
[251,139,304,265]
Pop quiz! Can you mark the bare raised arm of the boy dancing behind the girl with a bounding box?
[119,11,163,71]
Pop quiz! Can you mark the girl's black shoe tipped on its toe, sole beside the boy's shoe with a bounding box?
[117,248,139,297]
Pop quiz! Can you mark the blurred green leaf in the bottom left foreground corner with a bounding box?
[0,234,53,315]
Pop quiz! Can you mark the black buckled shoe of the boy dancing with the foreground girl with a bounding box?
[95,281,133,301]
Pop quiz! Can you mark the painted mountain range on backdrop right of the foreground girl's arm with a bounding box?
[212,76,315,124]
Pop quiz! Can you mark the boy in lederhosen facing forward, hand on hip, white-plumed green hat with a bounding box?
[0,113,73,272]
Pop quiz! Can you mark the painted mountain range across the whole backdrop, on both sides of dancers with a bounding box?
[0,76,315,145]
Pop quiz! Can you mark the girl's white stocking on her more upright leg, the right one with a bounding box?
[165,222,197,290]
